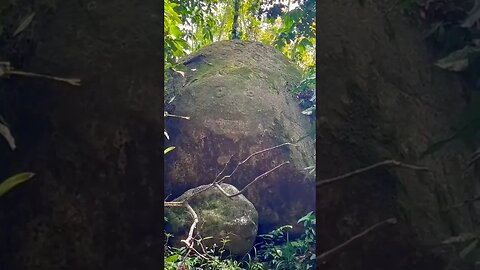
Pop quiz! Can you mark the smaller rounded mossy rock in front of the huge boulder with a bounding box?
[165,184,258,256]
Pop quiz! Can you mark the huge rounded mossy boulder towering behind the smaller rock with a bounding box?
[164,41,315,234]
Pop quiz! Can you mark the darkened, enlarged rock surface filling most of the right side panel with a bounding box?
[317,0,479,269]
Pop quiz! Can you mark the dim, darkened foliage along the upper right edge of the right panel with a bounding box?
[403,0,480,157]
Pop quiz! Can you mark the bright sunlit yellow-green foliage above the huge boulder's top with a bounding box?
[164,0,316,70]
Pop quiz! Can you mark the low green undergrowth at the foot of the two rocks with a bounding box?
[164,212,316,270]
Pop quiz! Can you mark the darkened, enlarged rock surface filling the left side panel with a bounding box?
[0,0,163,270]
